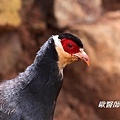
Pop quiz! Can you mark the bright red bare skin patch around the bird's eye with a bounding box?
[61,38,80,55]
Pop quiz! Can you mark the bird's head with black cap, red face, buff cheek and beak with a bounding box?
[53,33,90,69]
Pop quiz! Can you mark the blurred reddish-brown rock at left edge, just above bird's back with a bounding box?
[0,32,22,79]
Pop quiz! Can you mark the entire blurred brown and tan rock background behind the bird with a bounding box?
[0,0,120,120]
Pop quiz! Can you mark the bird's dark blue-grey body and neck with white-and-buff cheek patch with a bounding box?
[0,33,89,120]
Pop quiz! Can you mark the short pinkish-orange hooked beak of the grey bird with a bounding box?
[74,48,90,66]
